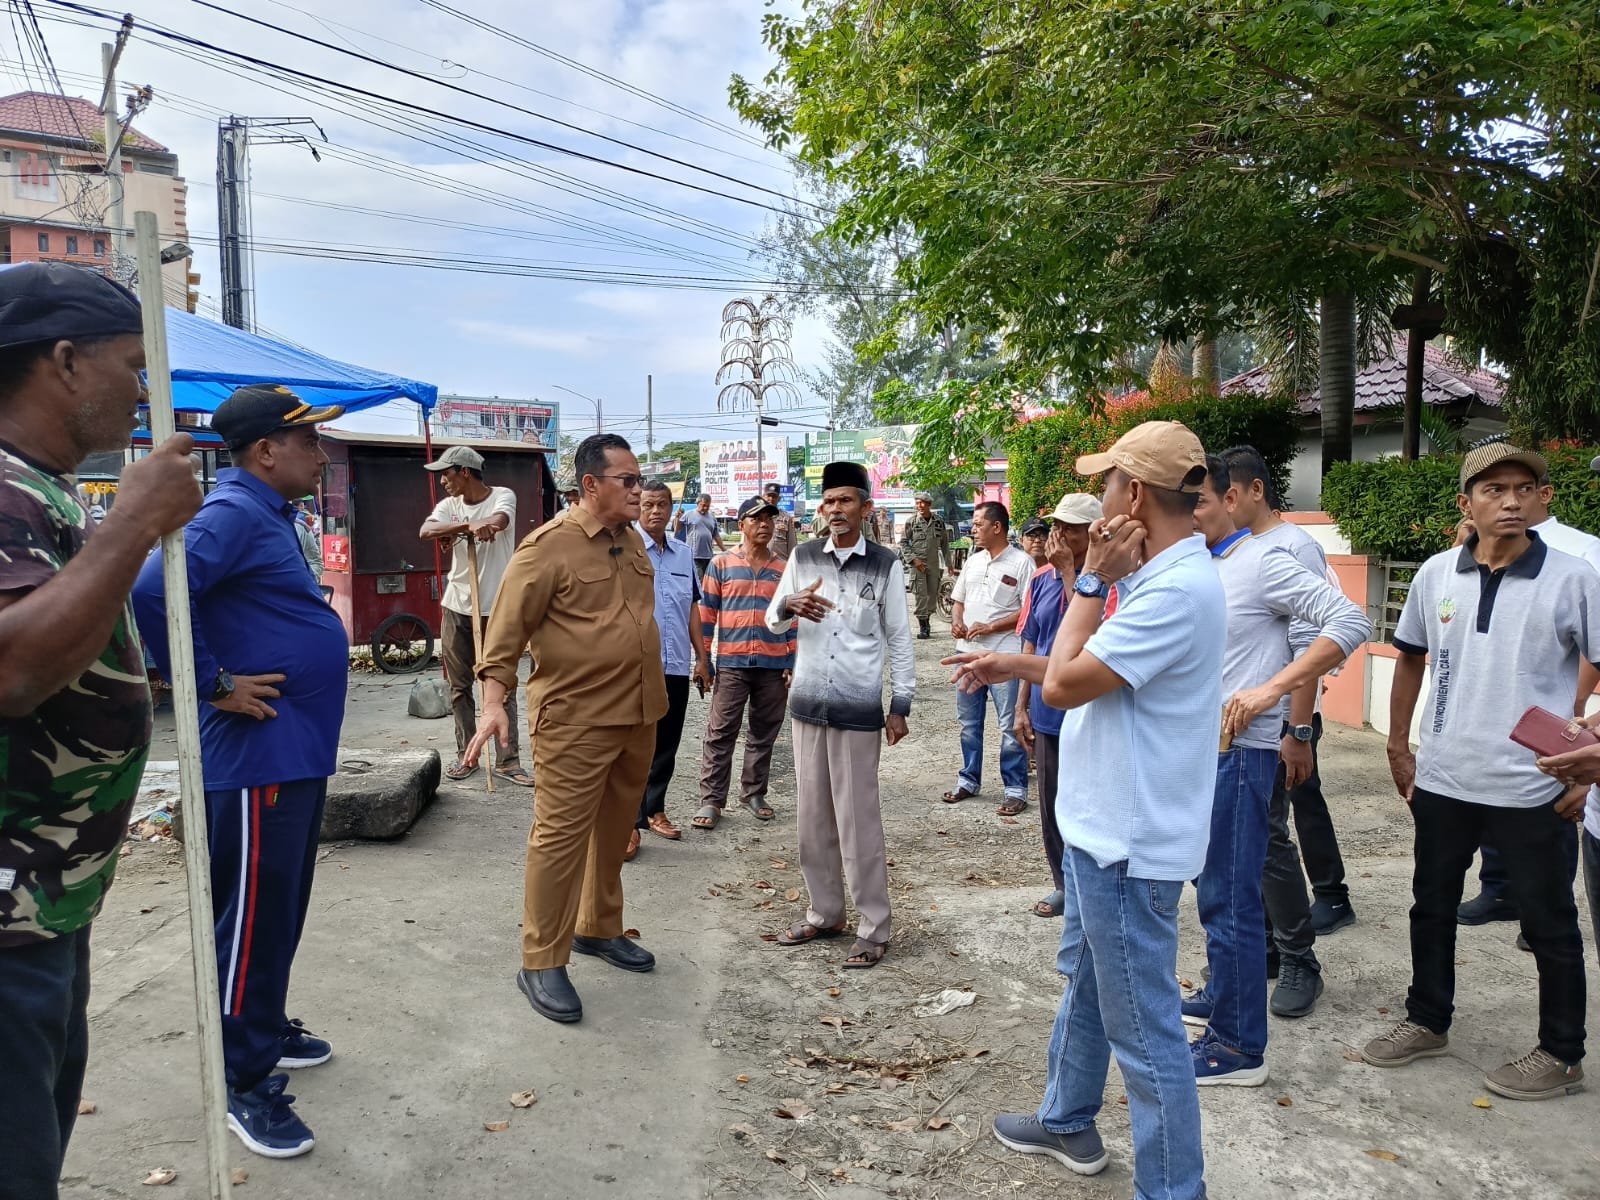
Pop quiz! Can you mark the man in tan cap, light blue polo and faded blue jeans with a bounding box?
[946,421,1227,1200]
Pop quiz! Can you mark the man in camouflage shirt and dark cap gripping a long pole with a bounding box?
[0,262,200,1200]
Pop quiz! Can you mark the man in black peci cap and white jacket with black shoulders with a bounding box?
[766,462,917,970]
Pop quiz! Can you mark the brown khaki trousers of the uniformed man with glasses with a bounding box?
[522,720,656,971]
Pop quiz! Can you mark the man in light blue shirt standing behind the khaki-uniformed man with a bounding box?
[622,480,710,862]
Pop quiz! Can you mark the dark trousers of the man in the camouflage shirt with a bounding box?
[0,926,90,1200]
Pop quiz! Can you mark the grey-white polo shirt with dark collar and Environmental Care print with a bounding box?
[1394,530,1600,808]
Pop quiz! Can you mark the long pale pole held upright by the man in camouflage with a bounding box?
[133,213,232,1200]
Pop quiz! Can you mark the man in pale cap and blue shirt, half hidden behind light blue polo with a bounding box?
[1016,491,1106,917]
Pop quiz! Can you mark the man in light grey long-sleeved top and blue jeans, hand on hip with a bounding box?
[1184,454,1371,1086]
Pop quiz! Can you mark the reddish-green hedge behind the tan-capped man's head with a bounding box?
[1006,394,1299,523]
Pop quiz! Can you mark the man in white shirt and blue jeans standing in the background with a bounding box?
[944,501,1034,816]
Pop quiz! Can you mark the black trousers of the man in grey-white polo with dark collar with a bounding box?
[1405,787,1584,1062]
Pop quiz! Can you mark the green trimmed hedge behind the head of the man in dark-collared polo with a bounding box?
[1322,446,1600,563]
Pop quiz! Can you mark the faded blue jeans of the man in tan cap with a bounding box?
[1038,846,1205,1200]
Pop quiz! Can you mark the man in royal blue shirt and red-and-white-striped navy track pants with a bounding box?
[133,386,349,1158]
